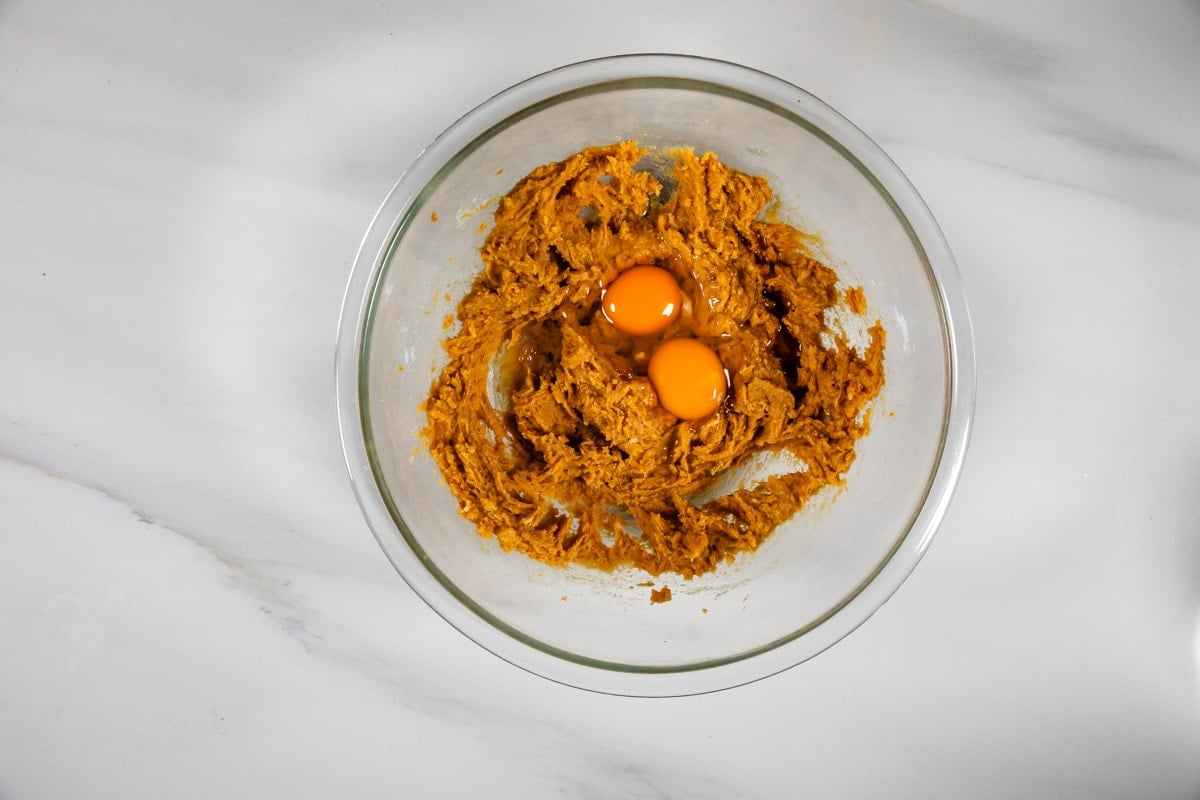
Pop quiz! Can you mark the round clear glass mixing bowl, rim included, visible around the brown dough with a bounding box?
[337,55,974,696]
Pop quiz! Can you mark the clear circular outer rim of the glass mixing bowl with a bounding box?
[335,54,976,697]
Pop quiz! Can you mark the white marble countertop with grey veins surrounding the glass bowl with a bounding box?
[0,0,1200,800]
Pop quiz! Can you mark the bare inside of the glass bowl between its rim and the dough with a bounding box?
[359,79,952,673]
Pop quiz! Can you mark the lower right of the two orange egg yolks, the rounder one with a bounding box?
[649,338,727,420]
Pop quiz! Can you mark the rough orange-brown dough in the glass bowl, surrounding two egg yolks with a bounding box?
[425,142,884,578]
